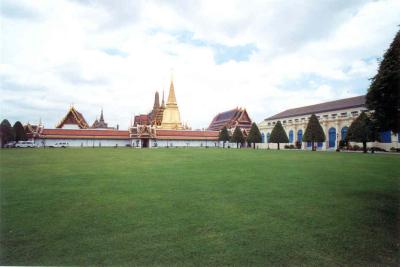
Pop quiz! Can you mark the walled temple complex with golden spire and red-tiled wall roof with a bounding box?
[26,77,219,147]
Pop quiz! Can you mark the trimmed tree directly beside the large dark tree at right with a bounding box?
[346,112,378,153]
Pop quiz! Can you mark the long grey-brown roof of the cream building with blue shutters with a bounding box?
[265,95,365,120]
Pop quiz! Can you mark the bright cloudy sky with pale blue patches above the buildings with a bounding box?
[0,0,400,129]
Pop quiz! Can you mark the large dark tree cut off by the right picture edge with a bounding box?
[366,31,400,133]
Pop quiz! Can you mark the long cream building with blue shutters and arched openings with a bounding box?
[258,95,399,150]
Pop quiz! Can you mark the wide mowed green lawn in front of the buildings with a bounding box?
[0,148,400,266]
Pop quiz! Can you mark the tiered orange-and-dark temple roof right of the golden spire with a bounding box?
[208,108,252,131]
